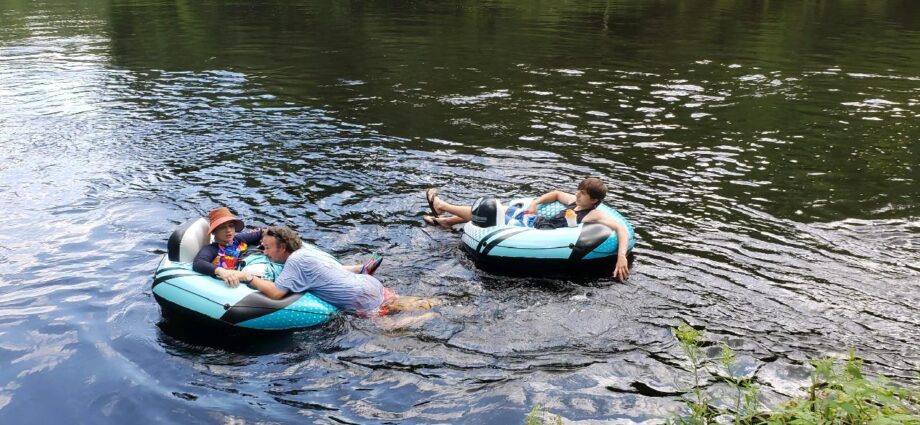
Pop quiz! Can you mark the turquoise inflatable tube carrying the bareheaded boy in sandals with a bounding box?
[461,198,636,276]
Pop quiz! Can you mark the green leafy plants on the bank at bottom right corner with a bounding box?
[670,324,920,425]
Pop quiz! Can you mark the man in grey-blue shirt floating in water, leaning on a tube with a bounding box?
[239,226,438,317]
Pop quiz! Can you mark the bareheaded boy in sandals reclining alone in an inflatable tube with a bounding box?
[422,177,629,282]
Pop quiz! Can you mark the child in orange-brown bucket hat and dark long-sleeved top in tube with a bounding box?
[192,207,265,286]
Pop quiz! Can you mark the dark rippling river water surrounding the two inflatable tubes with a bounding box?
[0,0,920,424]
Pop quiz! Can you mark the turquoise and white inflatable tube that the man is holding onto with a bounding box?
[153,218,338,331]
